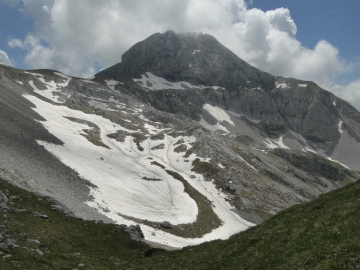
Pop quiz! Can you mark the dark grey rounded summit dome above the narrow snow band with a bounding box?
[96,30,275,89]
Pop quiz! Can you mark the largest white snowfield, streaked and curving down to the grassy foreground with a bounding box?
[25,95,253,247]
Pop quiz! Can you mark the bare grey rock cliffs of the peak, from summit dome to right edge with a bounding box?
[96,31,360,143]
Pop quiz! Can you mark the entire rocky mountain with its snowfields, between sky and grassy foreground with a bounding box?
[0,31,360,248]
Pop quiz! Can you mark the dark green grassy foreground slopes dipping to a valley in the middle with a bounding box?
[0,176,360,269]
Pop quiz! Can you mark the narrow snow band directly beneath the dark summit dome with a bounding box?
[133,72,225,90]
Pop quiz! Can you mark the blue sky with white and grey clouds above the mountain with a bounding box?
[0,0,360,108]
